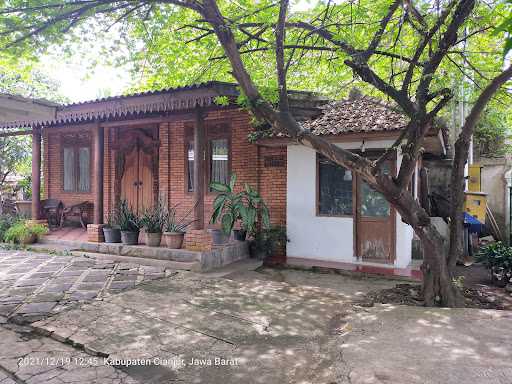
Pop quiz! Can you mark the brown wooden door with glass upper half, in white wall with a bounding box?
[356,164,395,263]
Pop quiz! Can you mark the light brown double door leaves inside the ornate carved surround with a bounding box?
[121,146,154,213]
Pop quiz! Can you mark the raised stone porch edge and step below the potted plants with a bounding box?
[36,228,249,272]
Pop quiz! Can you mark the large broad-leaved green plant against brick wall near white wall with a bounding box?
[210,174,270,235]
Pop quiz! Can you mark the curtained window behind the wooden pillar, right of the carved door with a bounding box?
[185,123,231,192]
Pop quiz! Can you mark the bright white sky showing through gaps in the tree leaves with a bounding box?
[40,0,318,103]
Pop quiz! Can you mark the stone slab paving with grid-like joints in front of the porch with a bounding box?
[0,250,171,323]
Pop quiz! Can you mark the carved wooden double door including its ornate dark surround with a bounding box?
[116,128,159,214]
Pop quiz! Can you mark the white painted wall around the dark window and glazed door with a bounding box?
[286,140,413,267]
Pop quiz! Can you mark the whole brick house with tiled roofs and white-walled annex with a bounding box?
[0,82,444,267]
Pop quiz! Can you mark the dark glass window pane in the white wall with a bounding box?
[318,158,352,216]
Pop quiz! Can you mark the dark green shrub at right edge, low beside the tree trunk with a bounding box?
[477,241,512,284]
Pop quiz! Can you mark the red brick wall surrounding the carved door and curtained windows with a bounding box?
[43,109,286,244]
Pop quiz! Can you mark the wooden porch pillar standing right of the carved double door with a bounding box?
[194,109,205,229]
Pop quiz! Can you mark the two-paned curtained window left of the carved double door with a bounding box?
[62,134,91,193]
